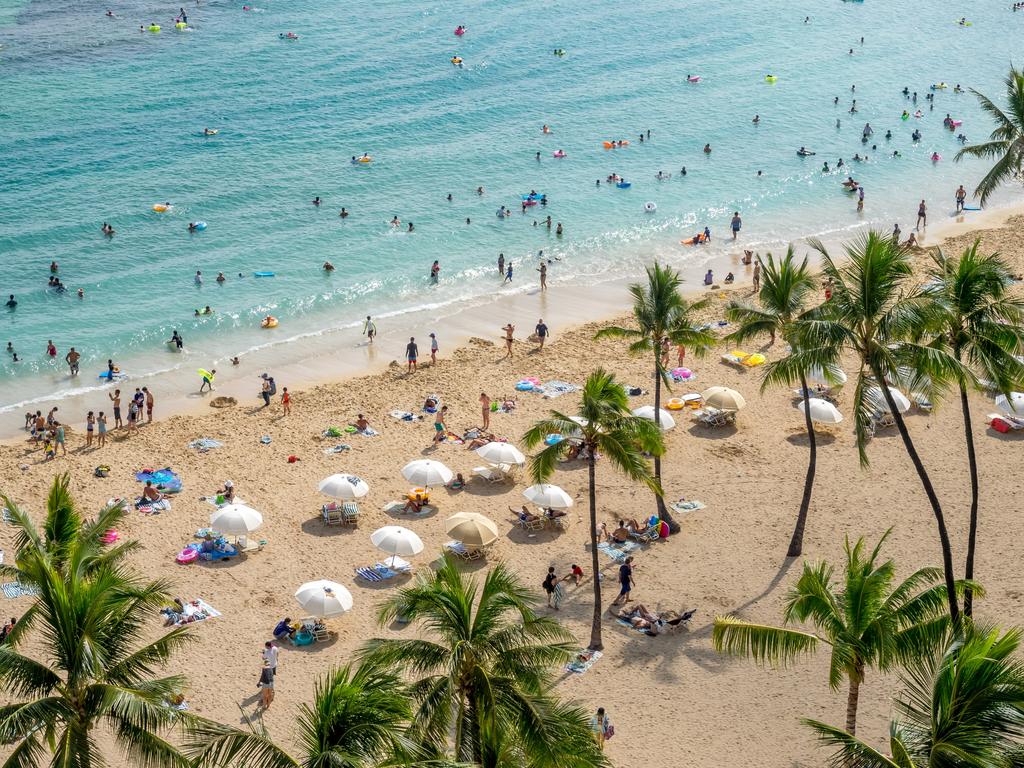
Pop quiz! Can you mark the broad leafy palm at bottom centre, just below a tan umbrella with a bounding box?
[360,555,605,768]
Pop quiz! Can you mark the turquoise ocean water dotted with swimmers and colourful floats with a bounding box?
[0,0,1024,411]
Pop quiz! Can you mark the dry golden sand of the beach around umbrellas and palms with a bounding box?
[0,211,1024,768]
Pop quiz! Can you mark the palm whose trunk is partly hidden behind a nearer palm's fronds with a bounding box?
[596,261,715,534]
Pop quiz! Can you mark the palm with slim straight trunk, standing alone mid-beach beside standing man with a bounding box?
[522,369,665,650]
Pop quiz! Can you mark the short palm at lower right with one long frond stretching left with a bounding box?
[712,531,970,733]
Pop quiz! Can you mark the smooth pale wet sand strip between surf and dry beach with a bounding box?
[6,195,1024,443]
